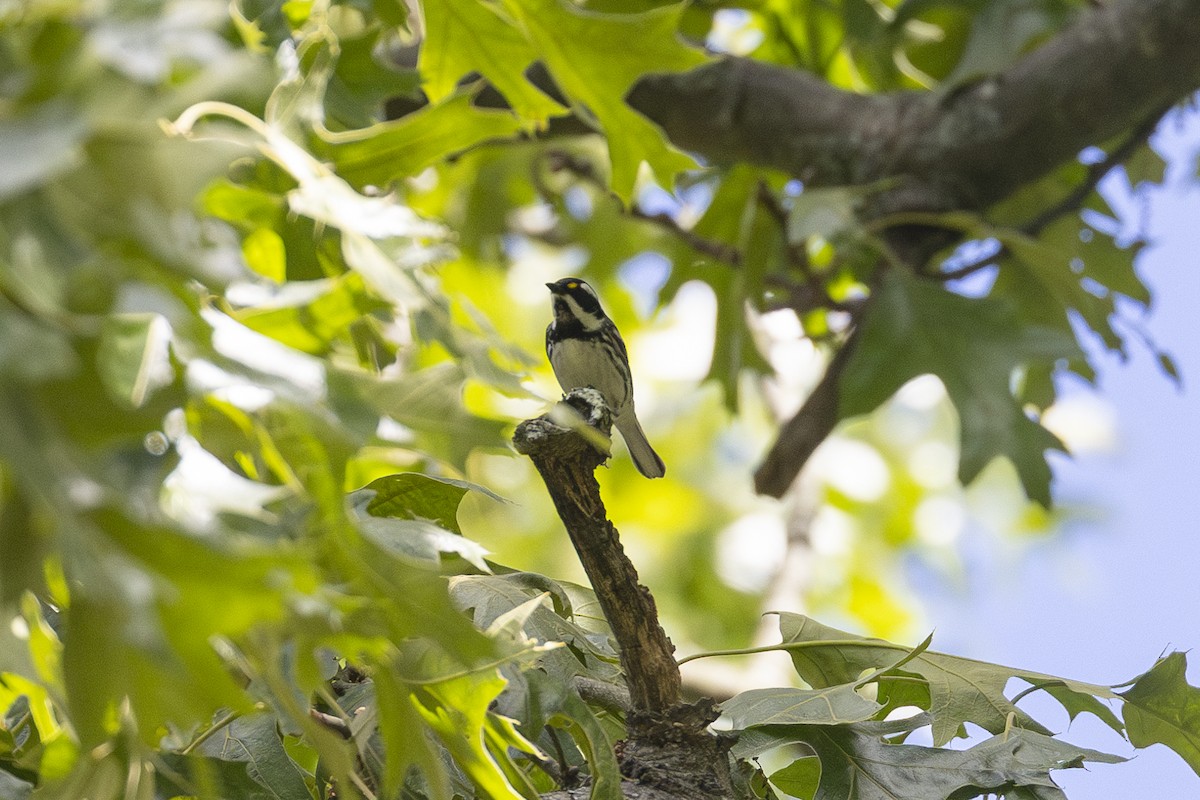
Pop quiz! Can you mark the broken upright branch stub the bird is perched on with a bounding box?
[512,389,733,798]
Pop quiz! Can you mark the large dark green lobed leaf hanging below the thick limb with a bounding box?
[840,270,1080,506]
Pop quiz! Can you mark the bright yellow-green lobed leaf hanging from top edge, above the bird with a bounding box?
[504,0,708,204]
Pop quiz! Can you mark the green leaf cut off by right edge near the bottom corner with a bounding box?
[1121,652,1200,774]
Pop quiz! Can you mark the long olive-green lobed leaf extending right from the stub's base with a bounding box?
[779,613,1116,746]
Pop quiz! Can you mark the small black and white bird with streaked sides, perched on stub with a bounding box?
[546,278,667,477]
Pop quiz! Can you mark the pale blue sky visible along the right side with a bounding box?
[930,109,1200,800]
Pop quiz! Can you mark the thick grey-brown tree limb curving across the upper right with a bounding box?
[629,0,1200,212]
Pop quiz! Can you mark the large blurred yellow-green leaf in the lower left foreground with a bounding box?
[64,510,317,747]
